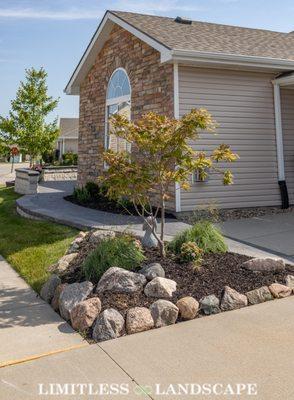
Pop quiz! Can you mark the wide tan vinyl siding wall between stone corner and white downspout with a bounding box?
[179,66,280,211]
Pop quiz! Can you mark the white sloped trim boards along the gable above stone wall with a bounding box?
[64,11,171,95]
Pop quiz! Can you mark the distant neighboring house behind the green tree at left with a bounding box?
[56,118,79,158]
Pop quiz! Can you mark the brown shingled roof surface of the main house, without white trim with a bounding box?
[110,11,294,60]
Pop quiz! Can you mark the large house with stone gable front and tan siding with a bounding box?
[65,11,294,212]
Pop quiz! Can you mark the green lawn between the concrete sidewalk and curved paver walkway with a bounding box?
[0,186,77,291]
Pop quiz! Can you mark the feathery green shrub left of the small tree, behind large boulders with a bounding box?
[82,235,145,283]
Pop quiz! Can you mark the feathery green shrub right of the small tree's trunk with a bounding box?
[168,221,227,254]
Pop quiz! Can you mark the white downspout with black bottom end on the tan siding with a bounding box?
[273,81,289,209]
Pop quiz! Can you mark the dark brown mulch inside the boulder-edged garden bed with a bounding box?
[63,240,293,314]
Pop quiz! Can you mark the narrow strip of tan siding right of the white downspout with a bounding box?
[281,88,294,204]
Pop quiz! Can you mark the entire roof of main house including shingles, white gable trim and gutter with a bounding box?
[65,11,294,94]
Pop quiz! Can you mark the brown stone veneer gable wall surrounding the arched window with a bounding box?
[78,25,174,208]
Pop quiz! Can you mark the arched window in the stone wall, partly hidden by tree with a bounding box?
[105,68,131,151]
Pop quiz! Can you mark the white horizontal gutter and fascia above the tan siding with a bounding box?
[172,50,294,71]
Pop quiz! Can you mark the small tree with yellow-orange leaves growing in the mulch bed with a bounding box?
[101,109,238,256]
